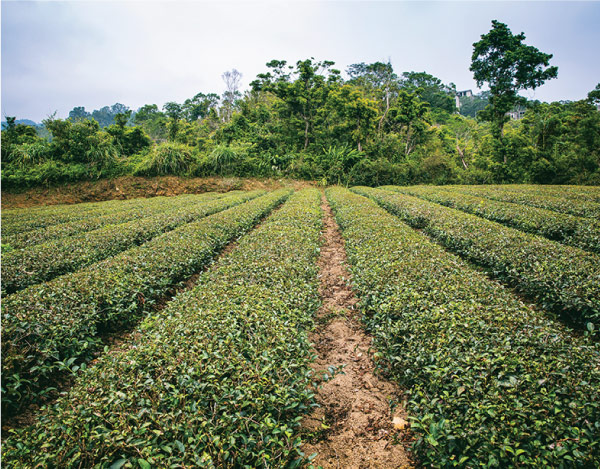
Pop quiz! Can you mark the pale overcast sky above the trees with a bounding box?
[2,0,600,122]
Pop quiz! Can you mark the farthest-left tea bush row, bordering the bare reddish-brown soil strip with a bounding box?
[2,197,192,238]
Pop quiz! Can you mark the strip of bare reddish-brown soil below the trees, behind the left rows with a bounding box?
[2,176,312,209]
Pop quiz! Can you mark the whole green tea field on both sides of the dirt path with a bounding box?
[2,185,600,469]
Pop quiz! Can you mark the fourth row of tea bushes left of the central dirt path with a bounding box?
[2,193,222,249]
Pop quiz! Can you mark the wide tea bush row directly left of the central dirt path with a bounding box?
[2,189,321,468]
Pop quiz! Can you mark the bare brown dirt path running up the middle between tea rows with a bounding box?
[302,196,413,469]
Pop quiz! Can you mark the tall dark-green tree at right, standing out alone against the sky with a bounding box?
[470,20,558,163]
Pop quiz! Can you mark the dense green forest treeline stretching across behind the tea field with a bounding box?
[2,49,600,188]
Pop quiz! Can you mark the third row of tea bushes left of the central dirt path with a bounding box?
[2,190,264,294]
